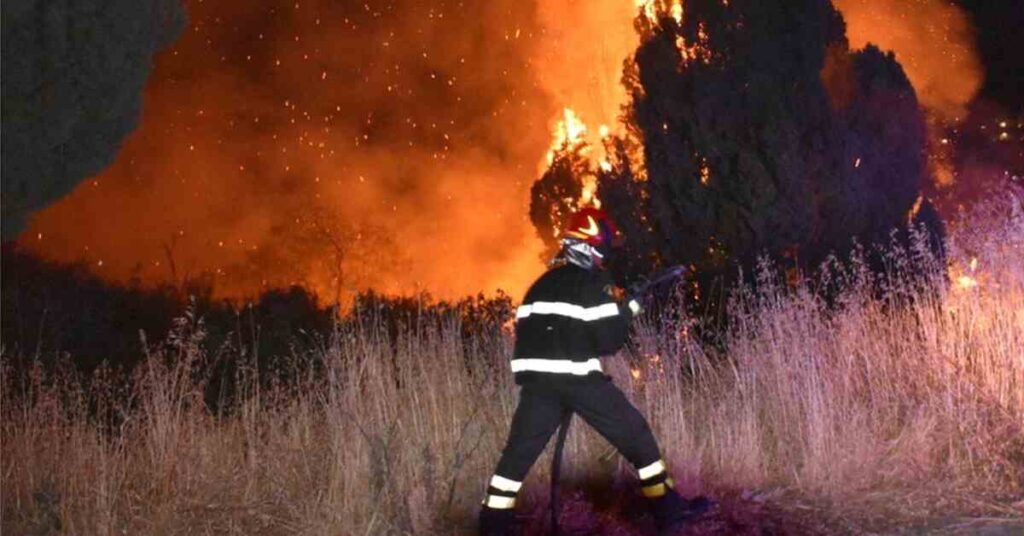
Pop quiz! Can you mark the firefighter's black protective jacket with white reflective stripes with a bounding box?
[512,262,632,384]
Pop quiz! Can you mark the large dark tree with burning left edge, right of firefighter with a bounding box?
[532,0,940,293]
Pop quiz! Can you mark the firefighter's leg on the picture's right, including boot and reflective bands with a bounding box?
[566,381,710,533]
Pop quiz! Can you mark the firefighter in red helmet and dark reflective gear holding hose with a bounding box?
[479,208,709,536]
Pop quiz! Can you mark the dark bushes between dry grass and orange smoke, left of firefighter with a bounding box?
[0,243,513,407]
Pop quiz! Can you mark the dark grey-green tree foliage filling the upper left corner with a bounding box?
[2,0,184,239]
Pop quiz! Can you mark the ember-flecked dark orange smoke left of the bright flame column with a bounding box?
[25,0,569,298]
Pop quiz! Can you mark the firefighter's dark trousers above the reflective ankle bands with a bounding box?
[495,379,660,482]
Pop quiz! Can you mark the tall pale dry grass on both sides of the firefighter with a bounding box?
[6,195,1024,535]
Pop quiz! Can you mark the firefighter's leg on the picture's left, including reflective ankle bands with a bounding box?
[480,384,562,536]
